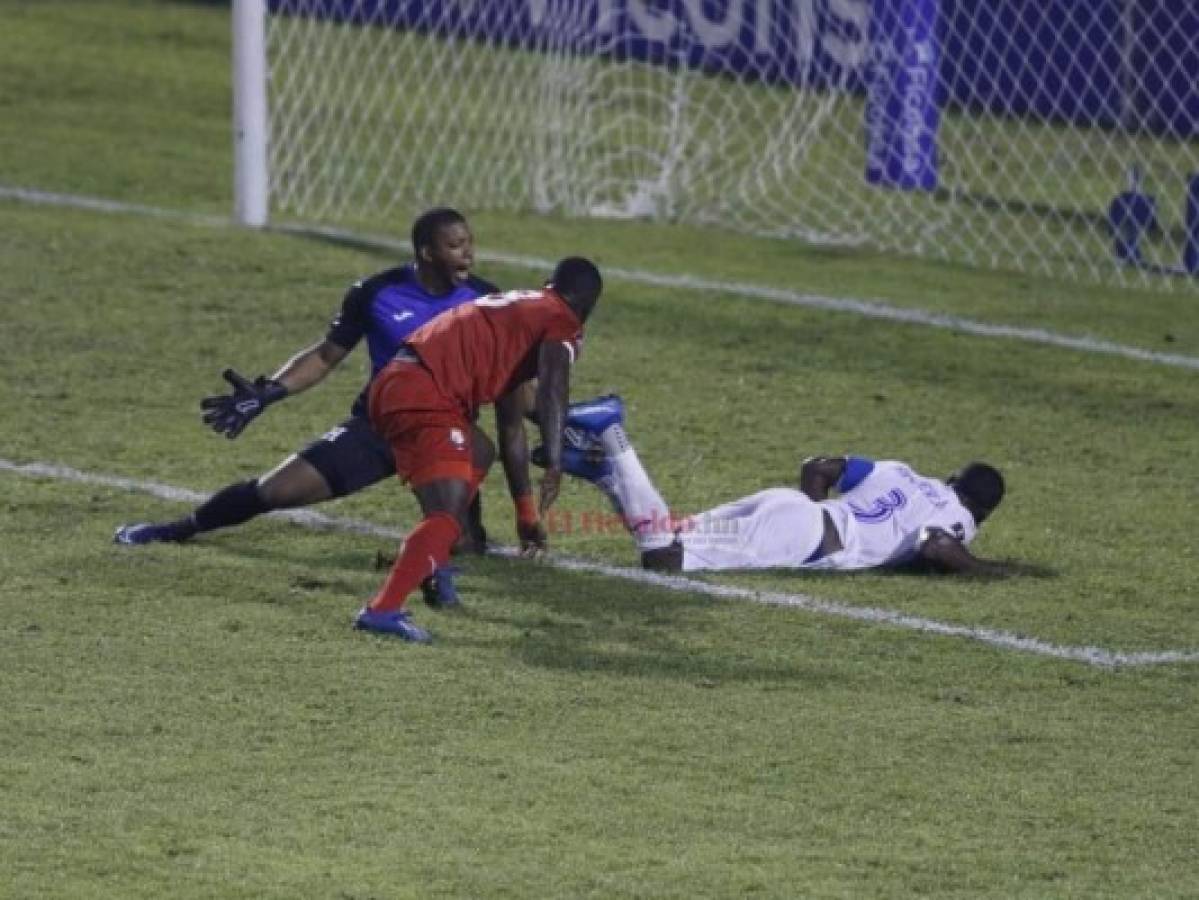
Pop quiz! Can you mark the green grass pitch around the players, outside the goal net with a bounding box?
[0,0,1199,900]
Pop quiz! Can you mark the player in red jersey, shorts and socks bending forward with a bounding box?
[355,256,603,642]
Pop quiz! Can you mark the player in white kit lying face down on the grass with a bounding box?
[544,395,1024,575]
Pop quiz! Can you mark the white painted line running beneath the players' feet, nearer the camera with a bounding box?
[0,458,1199,669]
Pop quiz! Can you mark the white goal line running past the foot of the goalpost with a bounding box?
[7,185,1199,369]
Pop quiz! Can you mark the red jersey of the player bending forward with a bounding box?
[405,288,583,410]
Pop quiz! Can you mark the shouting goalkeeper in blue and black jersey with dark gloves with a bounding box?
[115,209,496,602]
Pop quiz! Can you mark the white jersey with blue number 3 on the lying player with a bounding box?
[809,460,978,569]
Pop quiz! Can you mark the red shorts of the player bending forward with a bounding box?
[368,361,472,488]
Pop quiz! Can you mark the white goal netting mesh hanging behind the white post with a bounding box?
[267,0,1199,289]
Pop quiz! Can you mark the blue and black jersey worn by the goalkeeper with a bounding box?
[325,262,498,415]
